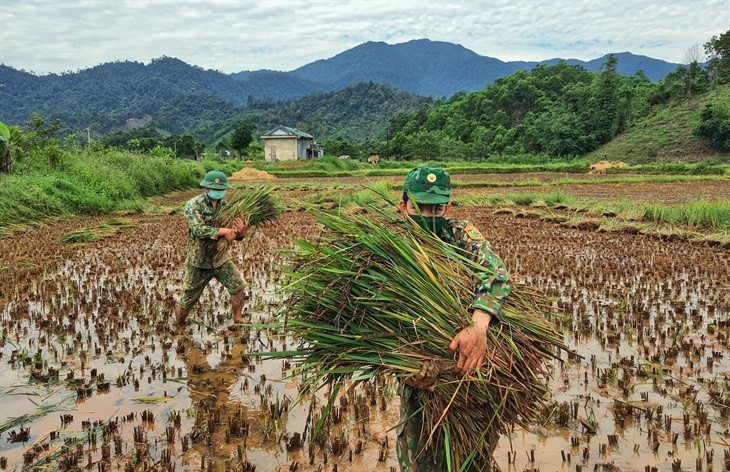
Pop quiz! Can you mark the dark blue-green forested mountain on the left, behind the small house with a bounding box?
[0,57,321,137]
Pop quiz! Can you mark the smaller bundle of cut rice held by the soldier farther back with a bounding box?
[213,187,281,254]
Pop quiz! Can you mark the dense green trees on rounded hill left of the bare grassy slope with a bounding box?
[385,58,652,160]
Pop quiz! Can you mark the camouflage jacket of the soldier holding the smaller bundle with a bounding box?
[185,193,231,269]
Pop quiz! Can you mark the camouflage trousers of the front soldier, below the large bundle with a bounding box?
[396,385,499,472]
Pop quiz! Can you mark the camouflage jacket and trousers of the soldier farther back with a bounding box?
[179,193,244,310]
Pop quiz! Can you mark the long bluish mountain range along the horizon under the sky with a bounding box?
[0,39,679,139]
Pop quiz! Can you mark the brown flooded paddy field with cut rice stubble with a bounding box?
[0,175,730,472]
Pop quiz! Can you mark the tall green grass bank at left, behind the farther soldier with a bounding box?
[0,150,243,227]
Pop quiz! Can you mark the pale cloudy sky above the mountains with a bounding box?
[0,0,730,74]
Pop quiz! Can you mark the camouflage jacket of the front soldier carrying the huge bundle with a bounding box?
[440,220,512,318]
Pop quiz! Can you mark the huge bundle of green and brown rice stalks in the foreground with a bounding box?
[276,198,566,470]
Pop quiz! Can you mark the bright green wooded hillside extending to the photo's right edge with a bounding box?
[385,46,730,161]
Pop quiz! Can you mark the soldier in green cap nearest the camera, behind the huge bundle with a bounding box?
[397,166,510,472]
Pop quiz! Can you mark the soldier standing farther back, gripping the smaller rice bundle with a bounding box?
[176,170,246,326]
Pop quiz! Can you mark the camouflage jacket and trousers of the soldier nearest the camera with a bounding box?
[396,220,511,472]
